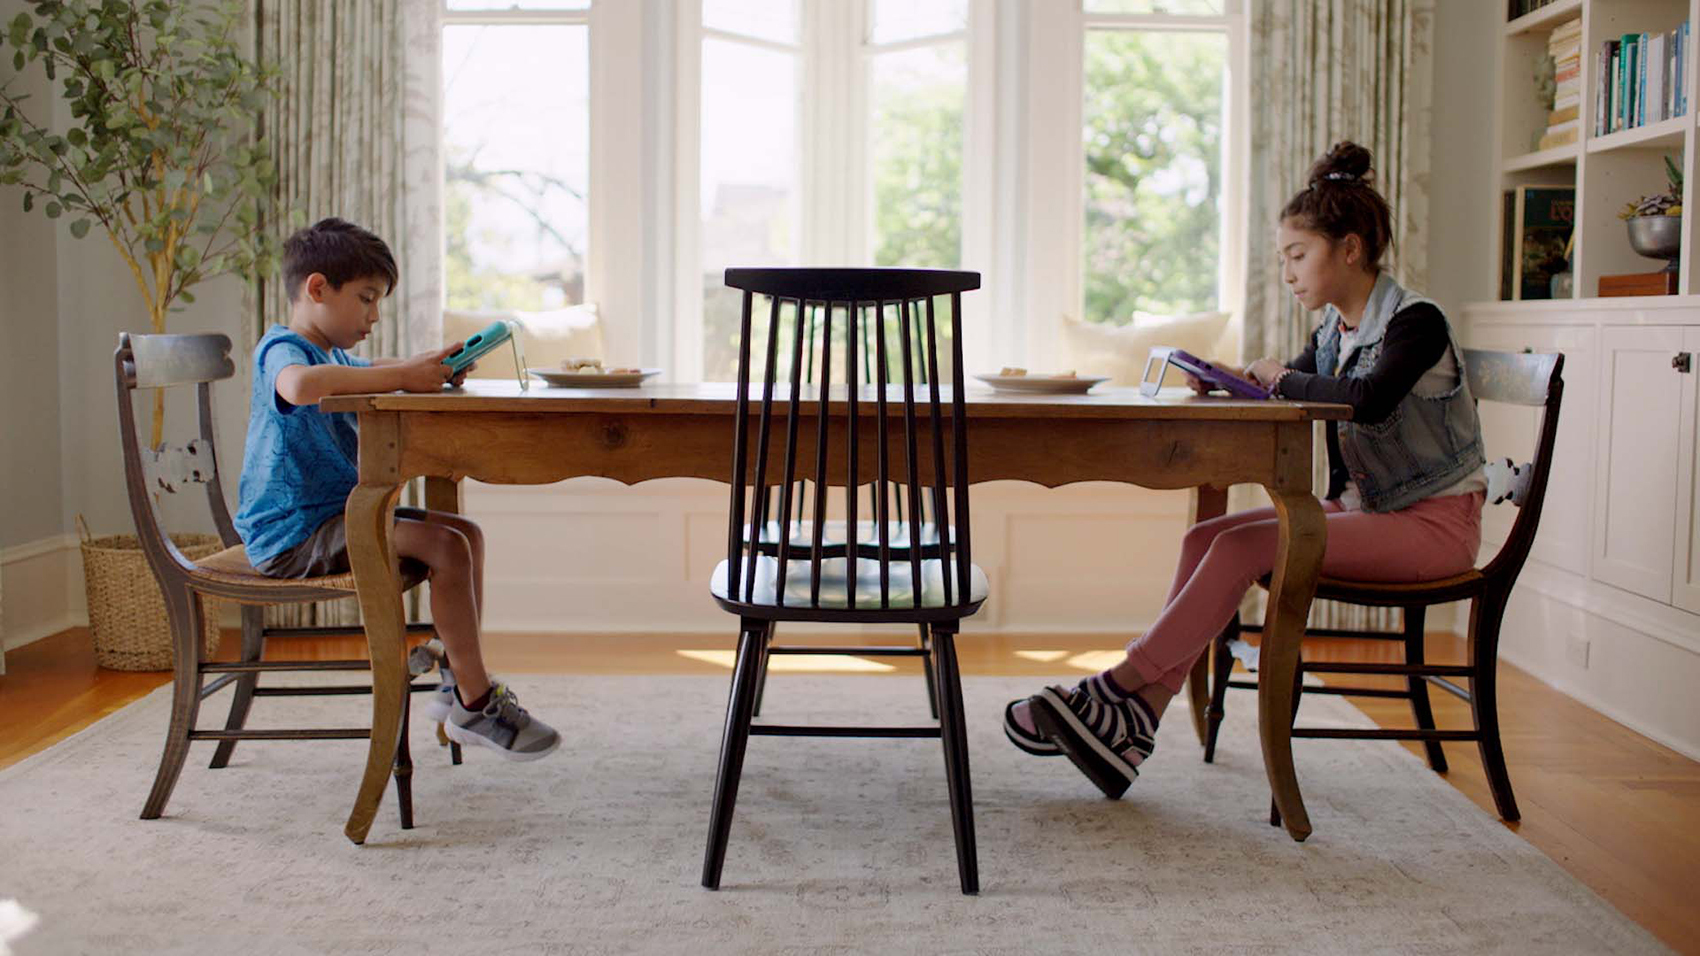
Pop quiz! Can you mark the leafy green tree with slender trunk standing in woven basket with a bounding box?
[0,0,277,669]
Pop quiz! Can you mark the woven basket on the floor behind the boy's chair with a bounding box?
[78,515,223,670]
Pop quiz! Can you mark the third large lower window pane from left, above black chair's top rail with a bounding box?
[869,43,967,269]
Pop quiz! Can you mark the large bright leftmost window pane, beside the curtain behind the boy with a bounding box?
[442,26,590,310]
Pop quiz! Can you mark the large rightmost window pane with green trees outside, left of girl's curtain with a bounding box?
[1083,31,1227,325]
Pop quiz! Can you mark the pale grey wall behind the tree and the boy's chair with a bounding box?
[0,0,247,648]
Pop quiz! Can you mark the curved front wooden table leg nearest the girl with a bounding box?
[1258,488,1328,840]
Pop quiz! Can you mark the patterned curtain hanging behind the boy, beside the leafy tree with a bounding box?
[247,0,442,626]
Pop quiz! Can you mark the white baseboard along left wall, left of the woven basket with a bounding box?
[0,534,88,650]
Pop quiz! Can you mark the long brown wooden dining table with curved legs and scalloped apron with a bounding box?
[320,379,1352,844]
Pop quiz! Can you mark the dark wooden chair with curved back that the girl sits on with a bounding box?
[1204,349,1564,825]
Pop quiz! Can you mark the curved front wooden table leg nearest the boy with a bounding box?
[343,485,408,844]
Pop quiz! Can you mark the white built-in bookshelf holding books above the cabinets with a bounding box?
[1489,0,1700,298]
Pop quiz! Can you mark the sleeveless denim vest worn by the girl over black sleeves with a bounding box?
[1316,272,1484,512]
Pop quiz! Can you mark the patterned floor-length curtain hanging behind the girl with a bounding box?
[1241,0,1435,628]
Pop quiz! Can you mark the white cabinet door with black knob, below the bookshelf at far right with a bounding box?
[1593,327,1693,602]
